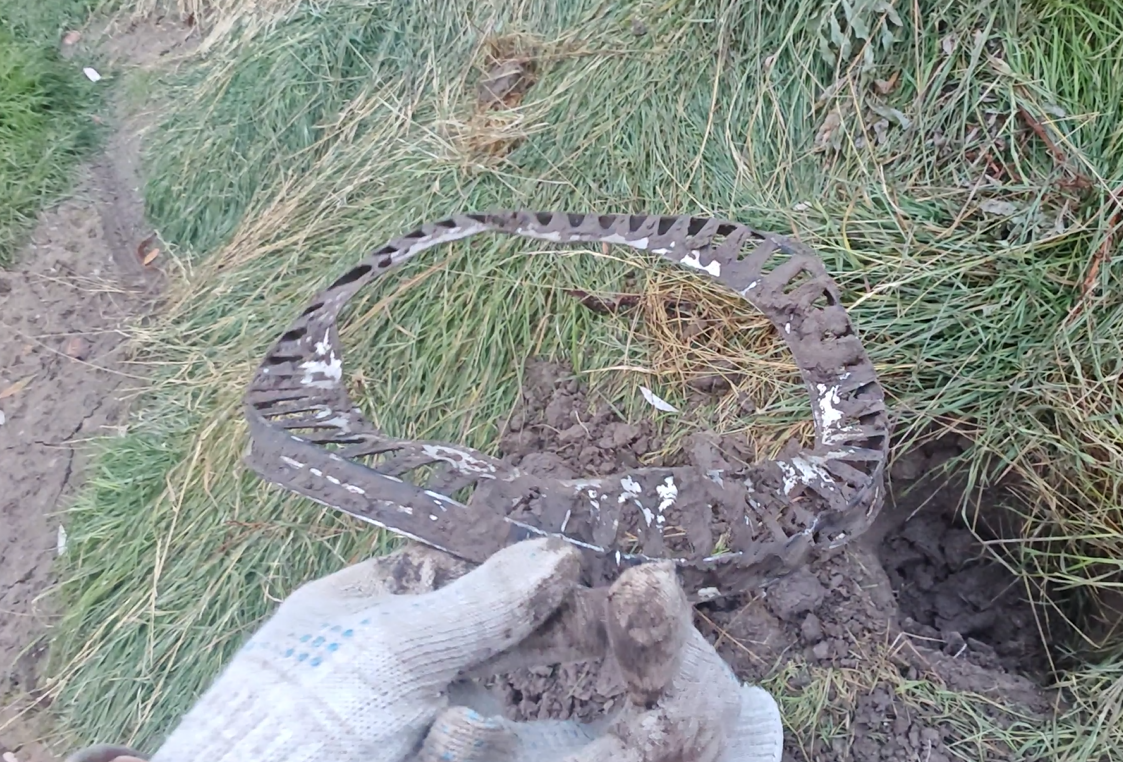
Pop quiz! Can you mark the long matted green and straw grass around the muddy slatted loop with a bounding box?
[41,0,1123,761]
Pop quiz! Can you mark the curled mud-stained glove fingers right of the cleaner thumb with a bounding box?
[418,562,784,762]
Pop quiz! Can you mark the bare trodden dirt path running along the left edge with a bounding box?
[0,19,190,762]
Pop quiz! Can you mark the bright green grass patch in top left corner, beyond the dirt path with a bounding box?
[0,0,103,266]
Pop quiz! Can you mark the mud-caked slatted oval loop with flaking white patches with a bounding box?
[245,211,889,600]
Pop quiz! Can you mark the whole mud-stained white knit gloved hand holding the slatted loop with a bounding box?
[67,540,783,762]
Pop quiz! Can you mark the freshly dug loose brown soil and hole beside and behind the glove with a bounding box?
[494,362,1053,762]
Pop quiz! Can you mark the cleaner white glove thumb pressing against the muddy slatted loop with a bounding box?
[377,539,581,685]
